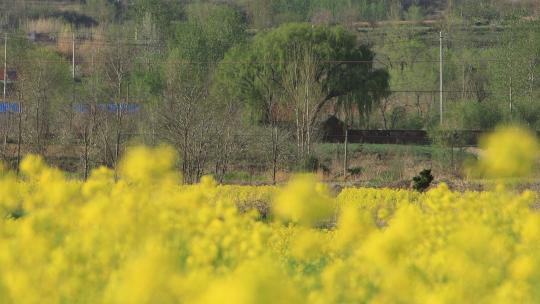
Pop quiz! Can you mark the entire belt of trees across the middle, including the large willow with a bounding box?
[0,0,540,182]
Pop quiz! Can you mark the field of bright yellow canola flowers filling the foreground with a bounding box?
[0,127,540,304]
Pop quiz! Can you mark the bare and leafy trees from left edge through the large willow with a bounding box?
[0,4,388,182]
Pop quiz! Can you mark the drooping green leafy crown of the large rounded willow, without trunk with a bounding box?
[216,23,388,123]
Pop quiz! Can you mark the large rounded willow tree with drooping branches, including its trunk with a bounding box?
[216,23,388,155]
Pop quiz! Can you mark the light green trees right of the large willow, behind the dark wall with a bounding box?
[355,17,540,129]
